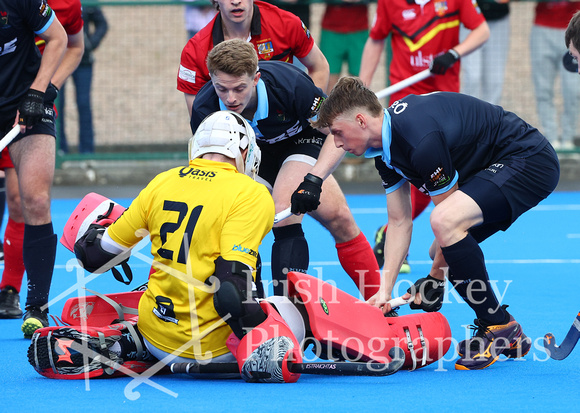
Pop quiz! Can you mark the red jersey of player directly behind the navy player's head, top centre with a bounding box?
[177,1,314,95]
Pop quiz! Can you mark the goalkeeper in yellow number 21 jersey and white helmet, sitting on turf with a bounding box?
[29,111,300,382]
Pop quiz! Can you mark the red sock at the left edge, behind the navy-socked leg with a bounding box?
[0,218,24,292]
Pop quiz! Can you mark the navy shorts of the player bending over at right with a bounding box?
[459,143,560,242]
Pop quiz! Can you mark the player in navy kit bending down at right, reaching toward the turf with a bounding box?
[293,77,560,370]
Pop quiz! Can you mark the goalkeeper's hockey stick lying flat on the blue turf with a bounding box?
[171,347,405,376]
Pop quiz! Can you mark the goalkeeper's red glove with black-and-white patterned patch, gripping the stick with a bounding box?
[227,301,302,383]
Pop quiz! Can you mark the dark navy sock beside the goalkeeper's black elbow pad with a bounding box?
[272,224,310,295]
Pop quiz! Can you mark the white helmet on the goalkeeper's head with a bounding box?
[189,110,262,179]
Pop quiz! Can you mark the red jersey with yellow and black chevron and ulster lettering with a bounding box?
[370,0,485,103]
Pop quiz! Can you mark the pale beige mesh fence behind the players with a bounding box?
[57,1,580,178]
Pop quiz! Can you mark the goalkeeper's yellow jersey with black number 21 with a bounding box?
[107,159,274,360]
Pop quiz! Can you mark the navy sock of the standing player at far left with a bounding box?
[22,222,57,307]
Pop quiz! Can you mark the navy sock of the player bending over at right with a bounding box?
[441,234,505,325]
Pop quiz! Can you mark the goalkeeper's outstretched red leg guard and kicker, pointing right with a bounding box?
[288,272,451,370]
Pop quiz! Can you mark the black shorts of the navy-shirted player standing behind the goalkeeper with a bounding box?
[258,135,324,189]
